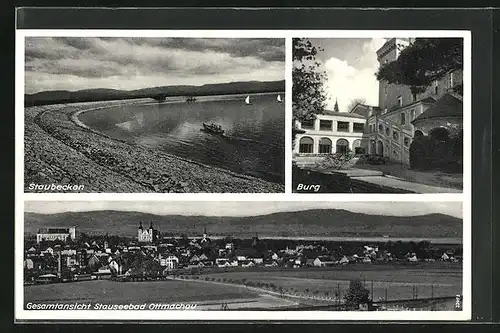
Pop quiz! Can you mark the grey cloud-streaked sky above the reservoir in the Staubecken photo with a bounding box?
[25,37,285,94]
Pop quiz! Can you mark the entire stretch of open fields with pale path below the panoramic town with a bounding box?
[24,265,462,310]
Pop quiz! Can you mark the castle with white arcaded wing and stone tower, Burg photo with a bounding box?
[294,38,463,164]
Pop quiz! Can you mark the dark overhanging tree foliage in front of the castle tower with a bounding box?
[376,38,463,94]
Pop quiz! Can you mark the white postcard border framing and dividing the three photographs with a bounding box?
[14,30,472,321]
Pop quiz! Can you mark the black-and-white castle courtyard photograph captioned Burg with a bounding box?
[292,36,470,193]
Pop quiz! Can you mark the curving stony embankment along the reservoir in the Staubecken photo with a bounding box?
[24,101,284,193]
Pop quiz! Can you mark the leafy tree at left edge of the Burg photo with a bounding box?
[292,38,326,121]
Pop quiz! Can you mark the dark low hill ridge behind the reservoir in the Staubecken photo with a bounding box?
[24,80,285,106]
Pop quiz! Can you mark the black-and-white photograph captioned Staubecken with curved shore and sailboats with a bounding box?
[24,36,286,193]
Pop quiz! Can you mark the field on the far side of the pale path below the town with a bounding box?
[199,264,462,301]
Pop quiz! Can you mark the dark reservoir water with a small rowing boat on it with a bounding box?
[79,93,285,183]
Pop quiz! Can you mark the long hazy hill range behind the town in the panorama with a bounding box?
[24,209,462,238]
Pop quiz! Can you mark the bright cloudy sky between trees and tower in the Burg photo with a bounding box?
[300,38,388,112]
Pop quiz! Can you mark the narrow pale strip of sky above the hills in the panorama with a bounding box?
[25,201,462,218]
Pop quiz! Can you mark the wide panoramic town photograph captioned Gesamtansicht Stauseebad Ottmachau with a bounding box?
[19,200,464,320]
